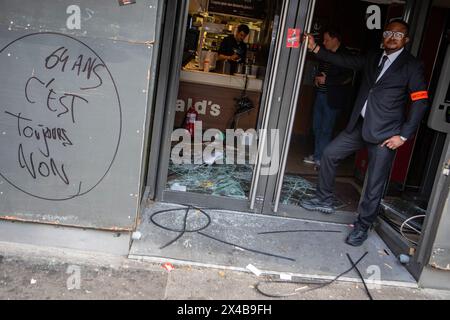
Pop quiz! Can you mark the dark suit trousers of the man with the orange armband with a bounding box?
[317,118,395,227]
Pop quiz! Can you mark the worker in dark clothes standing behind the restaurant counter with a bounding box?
[218,24,250,70]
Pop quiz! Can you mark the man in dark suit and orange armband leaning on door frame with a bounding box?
[301,20,428,246]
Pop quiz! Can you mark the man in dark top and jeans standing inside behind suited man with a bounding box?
[303,28,353,167]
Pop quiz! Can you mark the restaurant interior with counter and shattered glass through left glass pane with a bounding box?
[167,0,281,199]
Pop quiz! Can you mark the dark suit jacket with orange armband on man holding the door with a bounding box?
[317,48,428,144]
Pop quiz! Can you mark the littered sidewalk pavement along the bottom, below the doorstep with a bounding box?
[0,242,450,300]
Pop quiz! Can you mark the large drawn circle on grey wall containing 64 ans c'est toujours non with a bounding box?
[0,32,122,201]
